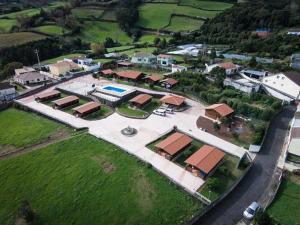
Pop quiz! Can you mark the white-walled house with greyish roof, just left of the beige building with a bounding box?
[13,71,50,85]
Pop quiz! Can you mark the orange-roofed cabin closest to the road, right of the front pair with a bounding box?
[184,145,225,178]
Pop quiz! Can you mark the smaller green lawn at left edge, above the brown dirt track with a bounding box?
[0,108,67,149]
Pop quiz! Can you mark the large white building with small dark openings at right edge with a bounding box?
[262,72,300,102]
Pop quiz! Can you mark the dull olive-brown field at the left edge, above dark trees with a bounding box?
[0,32,46,48]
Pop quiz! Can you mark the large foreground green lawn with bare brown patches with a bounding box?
[0,134,203,225]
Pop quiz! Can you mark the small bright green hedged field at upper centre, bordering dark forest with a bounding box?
[165,16,203,32]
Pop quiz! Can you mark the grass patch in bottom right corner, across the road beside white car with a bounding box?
[267,175,300,225]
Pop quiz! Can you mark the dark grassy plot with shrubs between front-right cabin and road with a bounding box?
[198,154,245,201]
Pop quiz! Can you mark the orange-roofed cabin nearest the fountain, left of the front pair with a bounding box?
[155,132,193,159]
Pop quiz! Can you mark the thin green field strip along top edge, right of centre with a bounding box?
[180,0,233,11]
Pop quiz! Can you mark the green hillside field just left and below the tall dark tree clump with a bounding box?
[80,22,132,44]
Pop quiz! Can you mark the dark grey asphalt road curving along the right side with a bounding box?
[195,106,295,225]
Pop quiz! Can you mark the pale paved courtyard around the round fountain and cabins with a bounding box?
[17,76,245,193]
